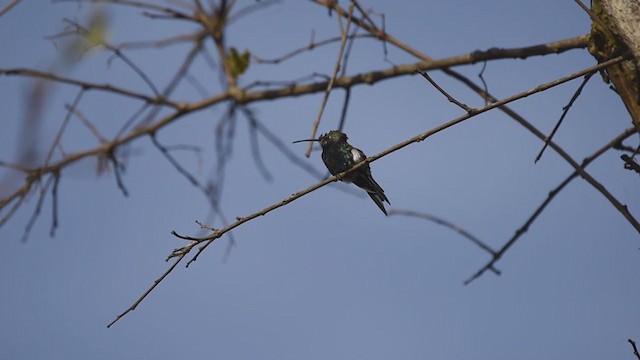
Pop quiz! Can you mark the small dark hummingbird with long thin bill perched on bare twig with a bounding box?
[294,130,391,215]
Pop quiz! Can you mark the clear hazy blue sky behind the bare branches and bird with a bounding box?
[0,0,640,359]
